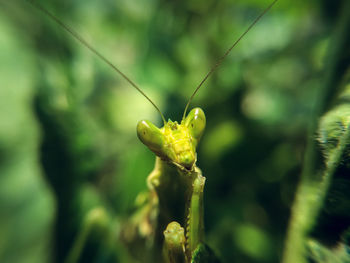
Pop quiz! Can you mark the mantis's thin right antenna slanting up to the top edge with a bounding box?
[182,0,278,120]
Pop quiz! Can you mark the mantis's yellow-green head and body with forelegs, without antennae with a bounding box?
[137,108,206,262]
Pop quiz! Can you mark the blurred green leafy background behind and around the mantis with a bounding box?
[0,0,341,263]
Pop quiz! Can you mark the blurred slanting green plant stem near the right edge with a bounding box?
[283,1,350,263]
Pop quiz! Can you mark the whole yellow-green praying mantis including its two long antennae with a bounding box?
[30,0,277,262]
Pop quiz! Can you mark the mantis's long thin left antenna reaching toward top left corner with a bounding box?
[28,0,166,124]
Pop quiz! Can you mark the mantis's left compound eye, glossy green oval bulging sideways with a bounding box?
[137,120,165,152]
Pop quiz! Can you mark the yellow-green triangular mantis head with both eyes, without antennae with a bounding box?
[137,108,206,170]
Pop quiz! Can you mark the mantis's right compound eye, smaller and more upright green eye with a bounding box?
[185,108,206,141]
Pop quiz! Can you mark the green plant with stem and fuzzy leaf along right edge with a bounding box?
[284,1,350,263]
